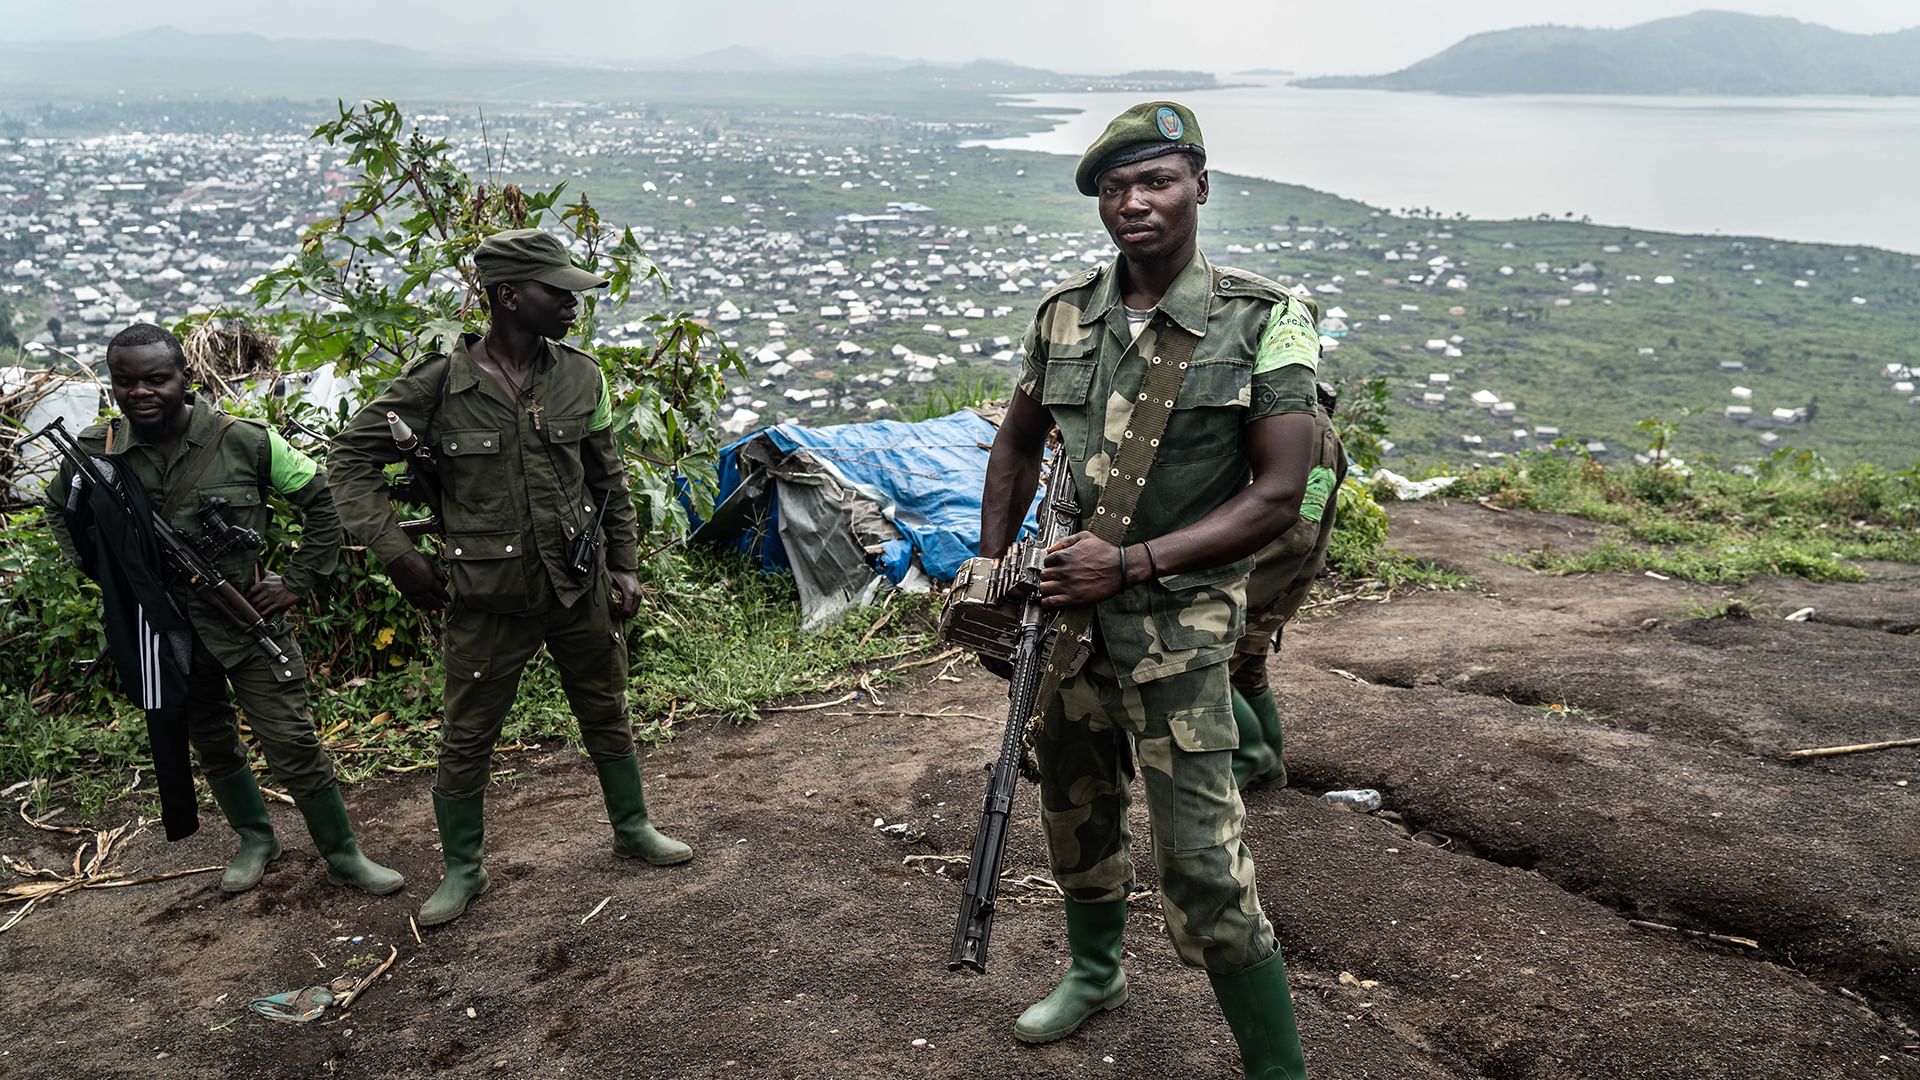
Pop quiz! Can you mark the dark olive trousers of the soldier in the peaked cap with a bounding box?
[434,573,634,799]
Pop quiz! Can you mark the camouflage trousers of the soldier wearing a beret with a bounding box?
[1033,651,1277,974]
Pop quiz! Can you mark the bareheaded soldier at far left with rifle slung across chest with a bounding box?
[46,323,407,896]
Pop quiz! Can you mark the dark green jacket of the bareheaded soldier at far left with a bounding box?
[46,394,340,665]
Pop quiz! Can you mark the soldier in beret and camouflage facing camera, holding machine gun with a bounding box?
[981,102,1331,1080]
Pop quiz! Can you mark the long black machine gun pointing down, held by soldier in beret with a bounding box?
[947,448,1083,972]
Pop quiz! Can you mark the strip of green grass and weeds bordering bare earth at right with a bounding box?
[1448,452,1920,584]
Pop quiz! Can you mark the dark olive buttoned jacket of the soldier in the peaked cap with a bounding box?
[326,334,639,613]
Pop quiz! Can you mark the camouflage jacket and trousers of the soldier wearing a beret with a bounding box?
[1020,254,1319,974]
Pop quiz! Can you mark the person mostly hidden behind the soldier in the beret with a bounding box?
[1227,394,1346,790]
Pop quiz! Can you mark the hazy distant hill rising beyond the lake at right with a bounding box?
[1296,12,1920,94]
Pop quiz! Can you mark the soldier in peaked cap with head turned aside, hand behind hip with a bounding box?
[328,229,693,926]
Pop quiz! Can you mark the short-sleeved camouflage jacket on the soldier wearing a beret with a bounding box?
[1020,254,1319,686]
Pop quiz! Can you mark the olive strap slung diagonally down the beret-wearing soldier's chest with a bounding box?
[1027,319,1200,726]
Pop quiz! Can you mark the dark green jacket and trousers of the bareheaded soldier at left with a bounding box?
[46,396,340,798]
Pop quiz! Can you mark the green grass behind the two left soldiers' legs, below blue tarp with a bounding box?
[0,550,935,815]
